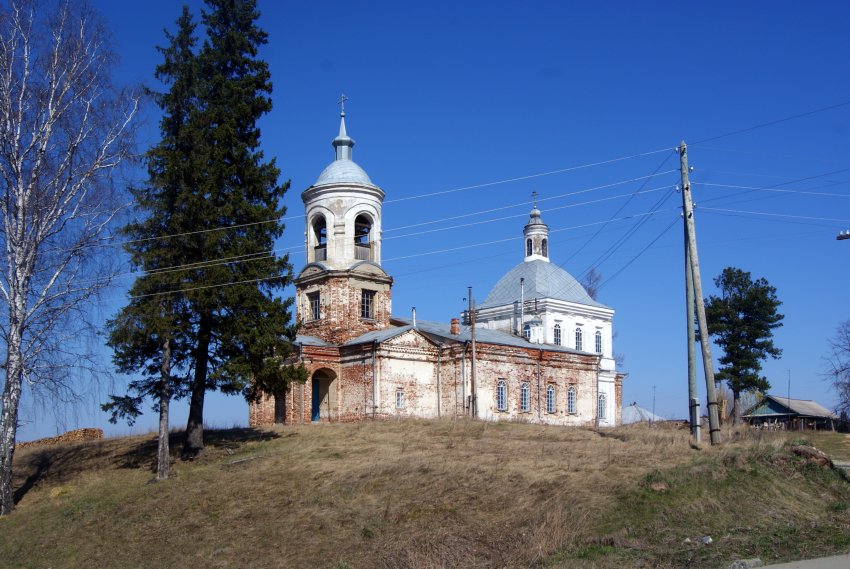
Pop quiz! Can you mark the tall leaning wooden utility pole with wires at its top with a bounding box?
[679,140,720,445]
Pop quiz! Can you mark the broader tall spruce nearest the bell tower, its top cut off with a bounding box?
[176,0,303,457]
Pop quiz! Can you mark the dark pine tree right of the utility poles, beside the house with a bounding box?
[705,267,785,423]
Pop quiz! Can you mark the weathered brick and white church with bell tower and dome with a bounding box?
[249,110,624,427]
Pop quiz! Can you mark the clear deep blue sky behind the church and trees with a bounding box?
[19,0,850,440]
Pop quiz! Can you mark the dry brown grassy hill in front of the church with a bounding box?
[0,421,850,569]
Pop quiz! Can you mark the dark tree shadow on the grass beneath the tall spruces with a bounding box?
[13,427,280,504]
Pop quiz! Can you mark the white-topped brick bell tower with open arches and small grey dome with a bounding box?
[295,95,393,344]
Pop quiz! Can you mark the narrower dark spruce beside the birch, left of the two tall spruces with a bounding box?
[103,6,199,480]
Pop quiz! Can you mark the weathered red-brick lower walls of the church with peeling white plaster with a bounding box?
[249,331,608,425]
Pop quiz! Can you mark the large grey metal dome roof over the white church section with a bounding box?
[479,259,607,308]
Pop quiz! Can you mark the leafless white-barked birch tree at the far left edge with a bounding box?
[0,0,139,515]
